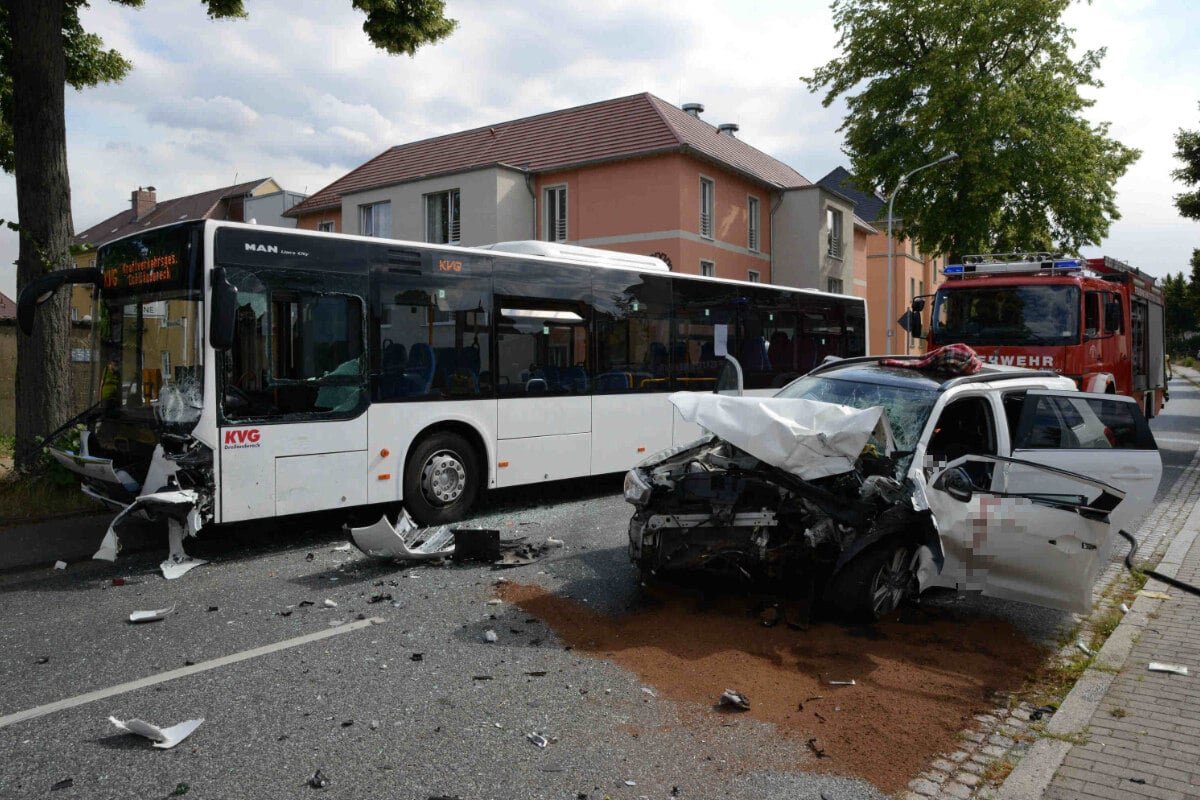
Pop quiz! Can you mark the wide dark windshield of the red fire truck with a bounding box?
[930,281,1080,345]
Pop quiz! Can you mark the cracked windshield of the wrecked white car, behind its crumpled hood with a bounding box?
[778,373,937,450]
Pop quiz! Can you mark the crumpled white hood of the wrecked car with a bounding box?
[670,392,895,481]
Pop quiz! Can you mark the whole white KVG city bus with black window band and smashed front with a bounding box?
[19,221,866,549]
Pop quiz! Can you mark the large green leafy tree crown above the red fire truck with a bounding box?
[805,0,1140,255]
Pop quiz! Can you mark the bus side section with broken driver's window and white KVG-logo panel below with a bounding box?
[217,266,368,522]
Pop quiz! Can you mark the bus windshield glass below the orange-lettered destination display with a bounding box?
[92,293,204,432]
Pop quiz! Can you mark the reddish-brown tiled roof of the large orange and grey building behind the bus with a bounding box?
[284,92,810,217]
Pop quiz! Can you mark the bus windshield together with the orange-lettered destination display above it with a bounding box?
[92,227,204,432]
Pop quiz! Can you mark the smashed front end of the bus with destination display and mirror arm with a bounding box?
[18,223,218,577]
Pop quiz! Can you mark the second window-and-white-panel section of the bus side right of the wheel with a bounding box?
[592,269,674,475]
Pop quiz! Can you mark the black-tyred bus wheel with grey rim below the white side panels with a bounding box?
[404,431,480,527]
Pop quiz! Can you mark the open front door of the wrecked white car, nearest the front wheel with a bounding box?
[926,455,1126,613]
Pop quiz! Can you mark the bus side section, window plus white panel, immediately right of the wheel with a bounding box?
[492,258,595,487]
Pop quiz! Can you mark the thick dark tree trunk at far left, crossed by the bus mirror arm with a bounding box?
[4,0,72,469]
